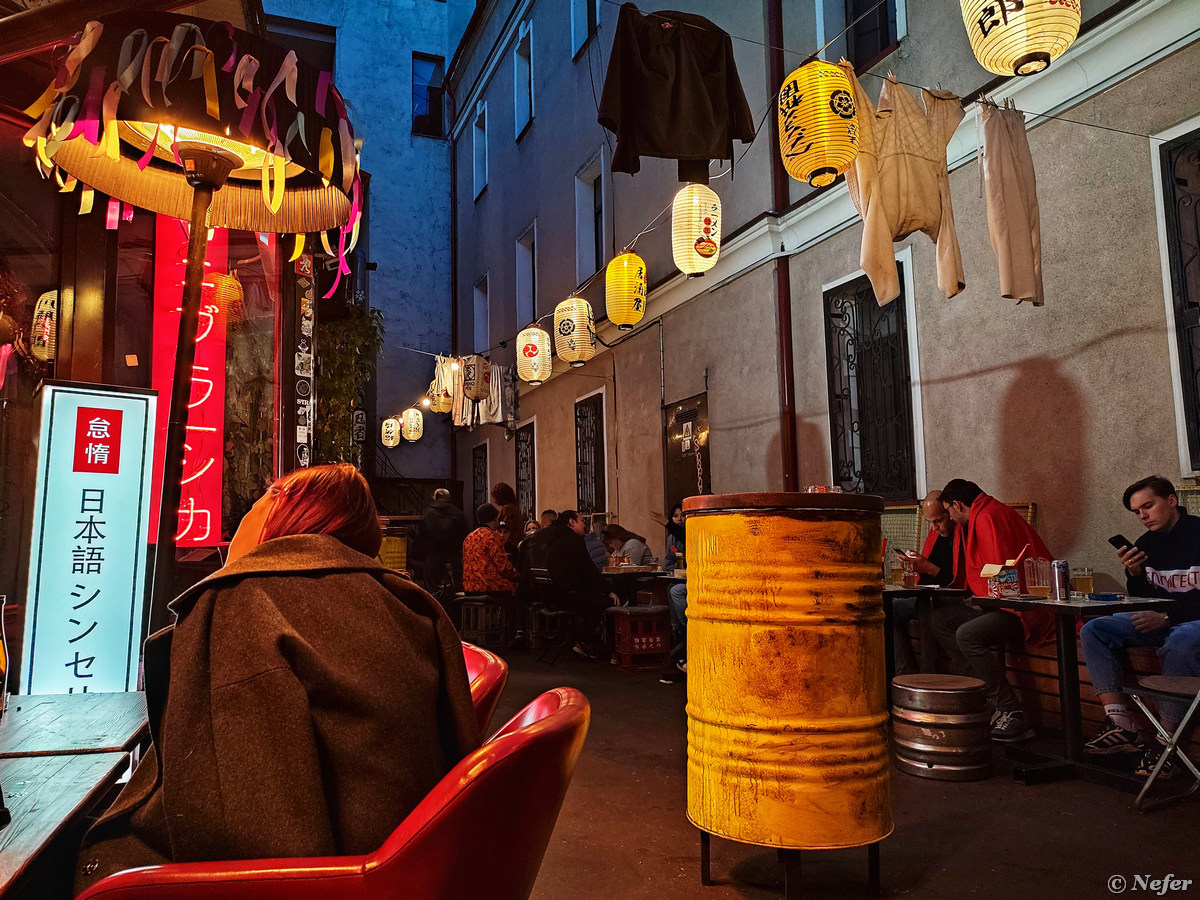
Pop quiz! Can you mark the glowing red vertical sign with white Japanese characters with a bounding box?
[150,216,229,547]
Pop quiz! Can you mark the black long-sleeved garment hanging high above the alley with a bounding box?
[598,4,754,184]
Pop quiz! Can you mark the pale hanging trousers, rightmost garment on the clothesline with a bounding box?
[980,103,1045,306]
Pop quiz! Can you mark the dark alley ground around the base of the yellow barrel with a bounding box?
[482,652,1200,900]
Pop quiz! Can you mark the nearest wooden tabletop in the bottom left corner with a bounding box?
[0,752,130,894]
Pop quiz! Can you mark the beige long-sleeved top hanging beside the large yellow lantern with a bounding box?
[839,60,966,306]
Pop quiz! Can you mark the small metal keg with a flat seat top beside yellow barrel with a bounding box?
[892,674,991,781]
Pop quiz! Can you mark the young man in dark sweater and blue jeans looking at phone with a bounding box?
[1079,475,1200,778]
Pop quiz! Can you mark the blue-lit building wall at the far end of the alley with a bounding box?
[263,0,472,478]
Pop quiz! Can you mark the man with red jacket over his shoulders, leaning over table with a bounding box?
[932,478,1055,742]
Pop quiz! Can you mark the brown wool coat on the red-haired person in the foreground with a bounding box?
[76,534,479,893]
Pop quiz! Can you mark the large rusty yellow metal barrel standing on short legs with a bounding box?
[683,493,893,850]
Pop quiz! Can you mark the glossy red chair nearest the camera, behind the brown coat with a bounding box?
[77,688,590,900]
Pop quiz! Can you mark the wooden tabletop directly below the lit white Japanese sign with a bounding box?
[0,691,149,763]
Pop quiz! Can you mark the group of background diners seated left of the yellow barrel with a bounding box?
[419,481,688,683]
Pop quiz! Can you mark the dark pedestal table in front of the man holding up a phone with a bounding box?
[971,595,1175,764]
